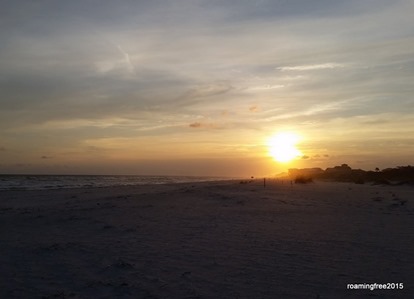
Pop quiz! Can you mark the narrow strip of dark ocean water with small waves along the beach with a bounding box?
[0,175,230,190]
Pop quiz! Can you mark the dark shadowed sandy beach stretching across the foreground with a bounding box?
[0,180,414,299]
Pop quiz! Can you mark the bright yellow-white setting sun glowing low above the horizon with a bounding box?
[268,132,302,163]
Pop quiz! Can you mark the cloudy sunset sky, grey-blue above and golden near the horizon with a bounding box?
[0,0,414,177]
